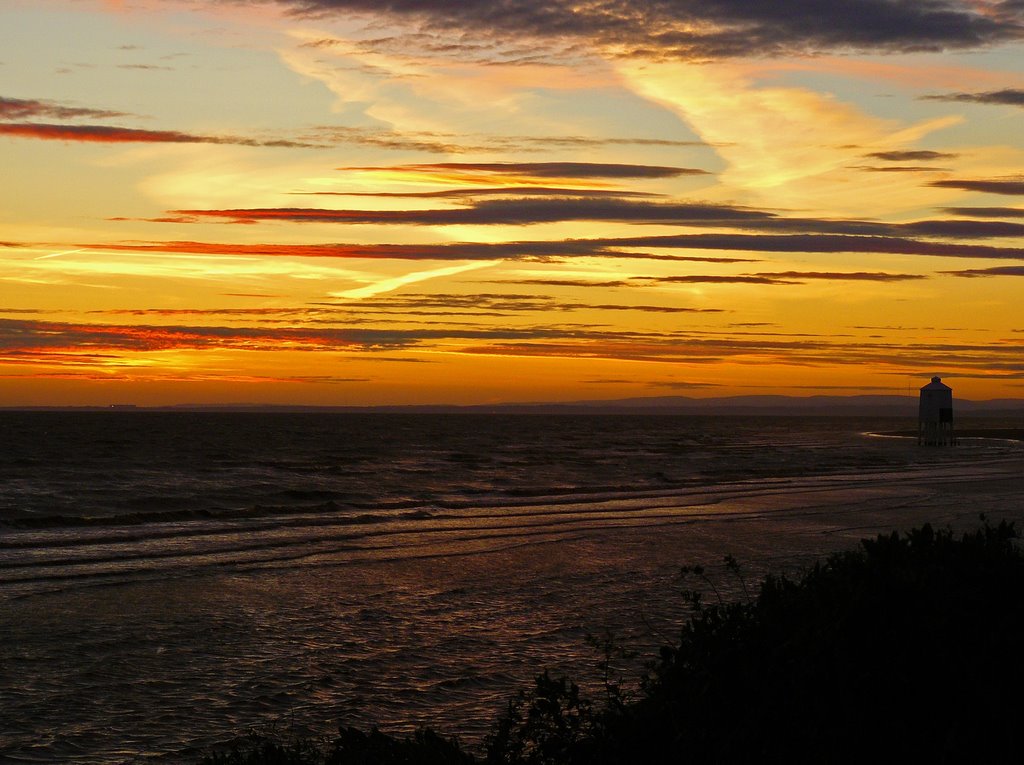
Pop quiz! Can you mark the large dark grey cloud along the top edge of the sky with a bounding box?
[268,0,1024,58]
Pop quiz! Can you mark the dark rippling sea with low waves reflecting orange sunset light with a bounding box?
[0,410,1024,765]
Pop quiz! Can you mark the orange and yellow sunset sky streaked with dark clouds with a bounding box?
[0,0,1024,406]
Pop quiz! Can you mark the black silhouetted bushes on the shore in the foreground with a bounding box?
[203,522,1024,765]
